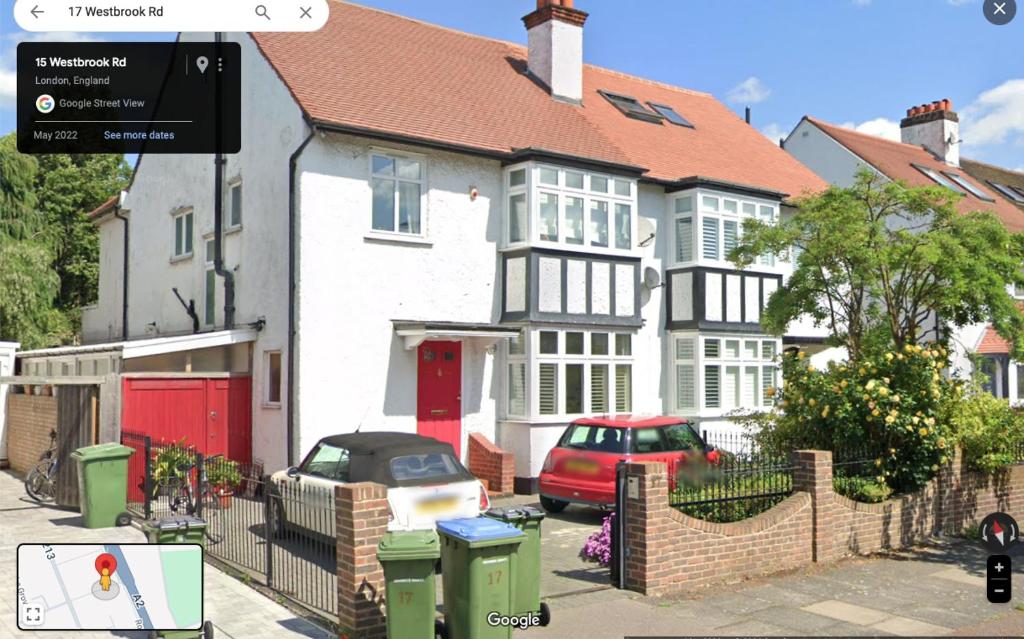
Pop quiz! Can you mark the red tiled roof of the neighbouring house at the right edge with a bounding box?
[807,116,1024,232]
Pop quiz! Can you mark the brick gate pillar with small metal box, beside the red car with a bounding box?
[623,462,671,595]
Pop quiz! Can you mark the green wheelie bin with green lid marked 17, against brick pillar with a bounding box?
[377,530,441,639]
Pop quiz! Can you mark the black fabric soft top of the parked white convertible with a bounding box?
[321,432,475,487]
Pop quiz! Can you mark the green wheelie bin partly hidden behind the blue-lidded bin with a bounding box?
[484,506,551,626]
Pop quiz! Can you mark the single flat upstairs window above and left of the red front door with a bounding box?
[372,154,423,236]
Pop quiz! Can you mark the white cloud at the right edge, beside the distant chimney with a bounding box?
[961,78,1024,146]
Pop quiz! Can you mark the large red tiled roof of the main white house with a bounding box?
[252,0,827,196]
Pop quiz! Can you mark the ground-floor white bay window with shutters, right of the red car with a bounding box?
[667,331,782,418]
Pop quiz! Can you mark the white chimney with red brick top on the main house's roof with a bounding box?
[522,0,587,102]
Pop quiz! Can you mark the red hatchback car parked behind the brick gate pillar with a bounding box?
[541,415,719,513]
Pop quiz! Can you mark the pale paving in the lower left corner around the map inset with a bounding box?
[0,471,335,639]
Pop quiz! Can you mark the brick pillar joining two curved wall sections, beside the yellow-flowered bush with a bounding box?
[793,451,844,562]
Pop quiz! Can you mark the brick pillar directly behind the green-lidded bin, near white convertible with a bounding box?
[334,481,388,639]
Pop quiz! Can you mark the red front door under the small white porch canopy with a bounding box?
[416,342,462,457]
